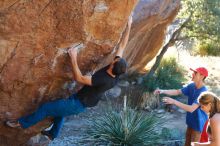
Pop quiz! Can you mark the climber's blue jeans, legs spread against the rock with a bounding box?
[18,94,85,138]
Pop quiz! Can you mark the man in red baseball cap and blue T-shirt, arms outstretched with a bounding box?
[154,67,208,146]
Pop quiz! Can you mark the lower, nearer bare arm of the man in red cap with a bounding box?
[163,97,199,113]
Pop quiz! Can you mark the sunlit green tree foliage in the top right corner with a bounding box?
[177,0,220,48]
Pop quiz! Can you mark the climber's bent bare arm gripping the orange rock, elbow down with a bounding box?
[68,48,92,86]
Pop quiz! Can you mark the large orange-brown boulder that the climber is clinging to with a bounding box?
[0,0,137,145]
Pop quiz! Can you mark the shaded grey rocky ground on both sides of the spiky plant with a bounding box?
[49,101,186,146]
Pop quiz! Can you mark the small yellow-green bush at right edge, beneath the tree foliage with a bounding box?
[196,41,220,56]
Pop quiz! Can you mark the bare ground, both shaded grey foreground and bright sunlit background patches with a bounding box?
[46,48,220,146]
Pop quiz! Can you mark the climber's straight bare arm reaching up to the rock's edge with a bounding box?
[116,16,132,57]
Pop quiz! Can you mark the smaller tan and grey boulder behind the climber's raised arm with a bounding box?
[125,0,180,71]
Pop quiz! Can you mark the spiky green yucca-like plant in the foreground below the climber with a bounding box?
[88,109,161,146]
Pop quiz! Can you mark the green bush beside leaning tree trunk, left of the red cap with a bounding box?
[143,58,186,92]
